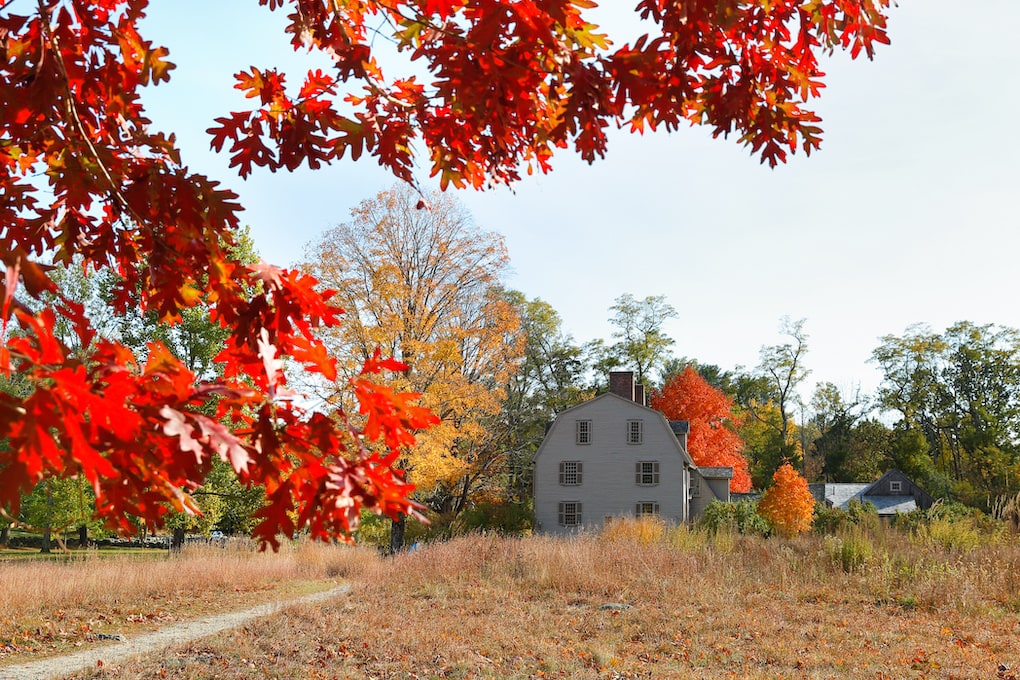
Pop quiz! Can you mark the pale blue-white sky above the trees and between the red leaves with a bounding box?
[137,0,1020,409]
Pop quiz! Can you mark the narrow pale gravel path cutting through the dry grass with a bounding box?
[0,585,350,680]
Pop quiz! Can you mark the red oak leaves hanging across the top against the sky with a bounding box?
[209,0,888,188]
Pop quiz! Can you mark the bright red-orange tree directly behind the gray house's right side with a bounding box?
[651,366,751,493]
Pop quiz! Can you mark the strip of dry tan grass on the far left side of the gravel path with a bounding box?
[0,541,377,660]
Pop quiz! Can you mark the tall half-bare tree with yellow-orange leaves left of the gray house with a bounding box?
[302,185,524,546]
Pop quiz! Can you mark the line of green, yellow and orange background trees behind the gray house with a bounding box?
[2,186,1020,547]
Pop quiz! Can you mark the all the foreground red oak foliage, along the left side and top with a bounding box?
[0,0,888,543]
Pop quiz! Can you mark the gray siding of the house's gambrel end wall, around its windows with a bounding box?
[534,394,690,533]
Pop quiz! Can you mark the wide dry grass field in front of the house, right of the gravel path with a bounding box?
[4,523,1020,680]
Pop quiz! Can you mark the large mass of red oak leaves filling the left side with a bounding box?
[0,0,436,545]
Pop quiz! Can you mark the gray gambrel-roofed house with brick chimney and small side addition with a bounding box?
[533,371,732,533]
